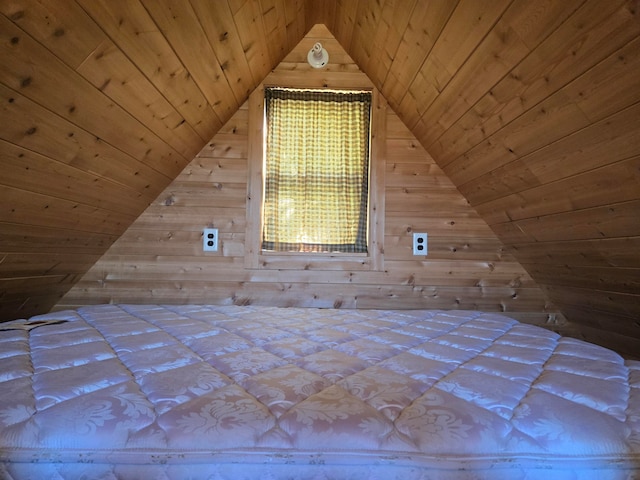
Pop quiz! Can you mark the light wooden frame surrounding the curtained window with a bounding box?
[245,84,386,271]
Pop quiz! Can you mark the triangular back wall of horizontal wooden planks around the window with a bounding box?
[61,26,563,328]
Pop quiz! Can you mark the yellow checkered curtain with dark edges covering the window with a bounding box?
[263,88,371,252]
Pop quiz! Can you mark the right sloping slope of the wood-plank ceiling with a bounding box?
[316,0,640,355]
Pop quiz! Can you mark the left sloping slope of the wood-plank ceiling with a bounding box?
[0,0,306,320]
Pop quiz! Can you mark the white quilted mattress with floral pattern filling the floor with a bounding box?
[0,305,640,480]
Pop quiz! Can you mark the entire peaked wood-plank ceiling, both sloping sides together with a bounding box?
[0,0,640,345]
